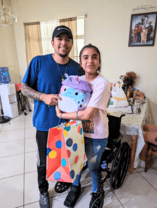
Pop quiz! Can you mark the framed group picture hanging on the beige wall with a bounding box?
[129,12,157,46]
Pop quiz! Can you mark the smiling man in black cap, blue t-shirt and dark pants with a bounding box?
[22,26,79,208]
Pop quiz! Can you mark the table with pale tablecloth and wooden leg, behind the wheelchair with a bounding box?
[108,101,147,174]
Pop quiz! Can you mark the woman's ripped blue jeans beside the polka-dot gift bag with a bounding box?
[73,137,108,192]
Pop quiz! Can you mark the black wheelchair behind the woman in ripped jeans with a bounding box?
[55,114,131,208]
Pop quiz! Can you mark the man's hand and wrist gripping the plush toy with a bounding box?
[40,93,62,105]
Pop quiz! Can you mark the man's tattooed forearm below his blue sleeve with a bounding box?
[21,83,42,100]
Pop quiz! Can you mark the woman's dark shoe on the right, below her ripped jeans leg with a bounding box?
[89,191,104,208]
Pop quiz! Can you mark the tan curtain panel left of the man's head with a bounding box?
[24,22,43,65]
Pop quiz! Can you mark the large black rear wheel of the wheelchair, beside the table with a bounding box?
[110,142,131,189]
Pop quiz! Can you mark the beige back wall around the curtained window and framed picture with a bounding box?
[12,0,157,124]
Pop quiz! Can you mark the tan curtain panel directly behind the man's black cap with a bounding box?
[59,17,78,61]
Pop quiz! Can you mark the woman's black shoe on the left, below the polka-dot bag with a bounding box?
[64,184,81,208]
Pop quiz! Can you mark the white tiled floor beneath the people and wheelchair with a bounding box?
[0,113,157,208]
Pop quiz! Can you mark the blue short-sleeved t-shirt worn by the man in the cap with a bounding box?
[22,54,79,131]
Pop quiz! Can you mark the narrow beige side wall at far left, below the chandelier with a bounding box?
[0,0,20,83]
